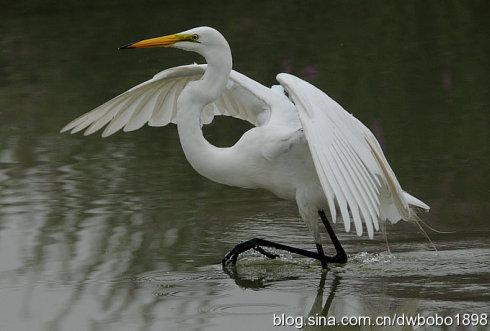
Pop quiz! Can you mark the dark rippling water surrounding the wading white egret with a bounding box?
[0,1,490,330]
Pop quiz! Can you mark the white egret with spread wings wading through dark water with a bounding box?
[61,26,430,268]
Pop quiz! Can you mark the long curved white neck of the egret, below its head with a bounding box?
[177,45,240,185]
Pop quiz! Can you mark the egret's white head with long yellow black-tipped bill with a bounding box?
[119,26,229,55]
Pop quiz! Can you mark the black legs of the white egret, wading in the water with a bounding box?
[221,210,347,268]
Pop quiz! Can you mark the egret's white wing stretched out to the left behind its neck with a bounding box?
[61,64,270,137]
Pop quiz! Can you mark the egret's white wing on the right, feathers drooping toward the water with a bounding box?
[277,74,410,238]
